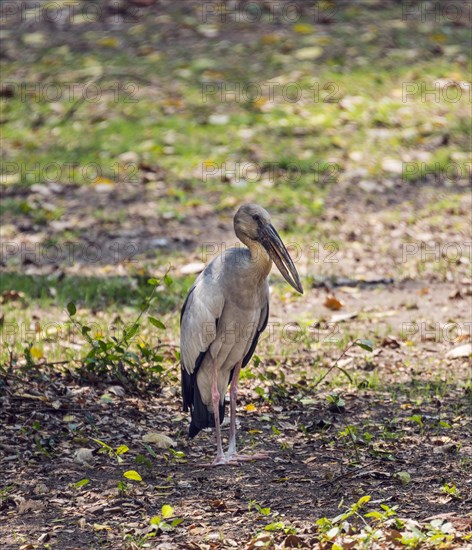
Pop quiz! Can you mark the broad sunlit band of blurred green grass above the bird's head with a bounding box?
[2,8,470,209]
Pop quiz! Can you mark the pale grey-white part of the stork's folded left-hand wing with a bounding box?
[180,272,224,374]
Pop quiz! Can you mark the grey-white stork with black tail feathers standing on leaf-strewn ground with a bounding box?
[180,203,303,466]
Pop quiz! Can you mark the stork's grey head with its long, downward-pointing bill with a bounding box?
[234,204,303,294]
